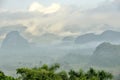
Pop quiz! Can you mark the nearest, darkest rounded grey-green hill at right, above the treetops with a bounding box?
[90,42,120,67]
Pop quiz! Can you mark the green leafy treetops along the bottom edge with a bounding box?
[0,64,113,80]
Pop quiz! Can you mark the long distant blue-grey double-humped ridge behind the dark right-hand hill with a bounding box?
[75,30,120,44]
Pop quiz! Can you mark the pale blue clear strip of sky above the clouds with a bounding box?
[0,0,105,10]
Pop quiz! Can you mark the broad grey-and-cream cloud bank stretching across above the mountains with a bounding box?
[0,0,120,41]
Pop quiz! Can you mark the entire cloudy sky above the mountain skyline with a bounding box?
[0,0,120,42]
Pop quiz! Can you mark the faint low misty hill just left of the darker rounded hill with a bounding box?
[57,53,90,70]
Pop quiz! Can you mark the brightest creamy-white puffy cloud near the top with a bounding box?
[29,2,61,14]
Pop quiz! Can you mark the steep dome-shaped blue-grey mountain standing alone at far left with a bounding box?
[1,31,30,49]
